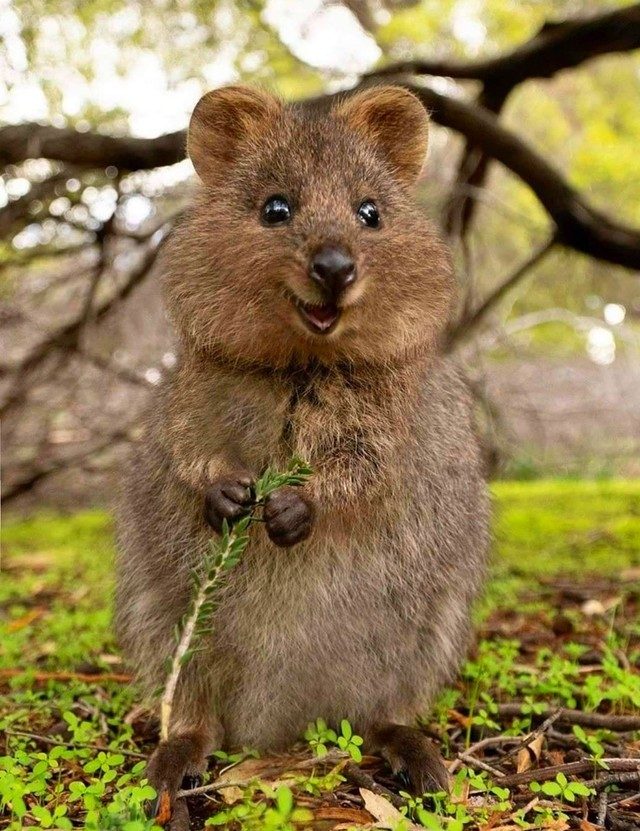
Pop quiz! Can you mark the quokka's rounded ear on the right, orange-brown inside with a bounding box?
[334,86,429,184]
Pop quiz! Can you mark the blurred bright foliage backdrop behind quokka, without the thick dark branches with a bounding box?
[0,0,640,504]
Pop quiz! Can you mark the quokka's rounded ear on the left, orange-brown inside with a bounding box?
[187,86,283,182]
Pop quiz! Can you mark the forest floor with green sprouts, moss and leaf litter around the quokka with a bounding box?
[0,481,640,831]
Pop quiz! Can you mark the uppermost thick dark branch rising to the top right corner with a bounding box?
[367,3,640,91]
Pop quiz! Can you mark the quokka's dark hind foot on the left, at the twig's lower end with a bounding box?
[146,735,206,831]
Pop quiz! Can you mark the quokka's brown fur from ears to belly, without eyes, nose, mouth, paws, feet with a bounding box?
[116,88,488,820]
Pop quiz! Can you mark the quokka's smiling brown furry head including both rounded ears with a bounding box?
[165,86,453,365]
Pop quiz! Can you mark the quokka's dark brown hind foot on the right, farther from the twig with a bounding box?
[368,724,449,796]
